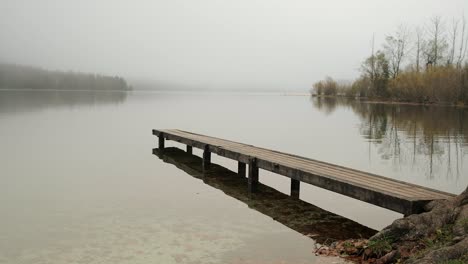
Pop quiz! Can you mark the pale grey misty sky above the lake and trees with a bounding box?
[0,0,468,90]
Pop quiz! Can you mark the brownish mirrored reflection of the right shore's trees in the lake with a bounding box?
[311,98,468,179]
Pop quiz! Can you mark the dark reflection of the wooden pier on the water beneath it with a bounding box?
[153,147,376,244]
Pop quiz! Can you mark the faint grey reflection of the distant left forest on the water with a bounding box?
[0,90,127,114]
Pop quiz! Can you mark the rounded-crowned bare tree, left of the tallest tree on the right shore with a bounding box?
[384,25,410,78]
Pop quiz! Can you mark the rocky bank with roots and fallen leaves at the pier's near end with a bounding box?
[316,187,468,264]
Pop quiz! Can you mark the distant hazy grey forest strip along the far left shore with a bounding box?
[0,63,131,91]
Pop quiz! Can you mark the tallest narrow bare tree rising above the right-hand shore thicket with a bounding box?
[424,16,447,67]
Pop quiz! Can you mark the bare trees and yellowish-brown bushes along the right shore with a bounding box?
[312,16,468,105]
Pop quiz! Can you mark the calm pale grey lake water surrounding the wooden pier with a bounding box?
[0,91,468,264]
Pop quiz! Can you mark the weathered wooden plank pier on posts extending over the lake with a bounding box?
[153,129,455,215]
